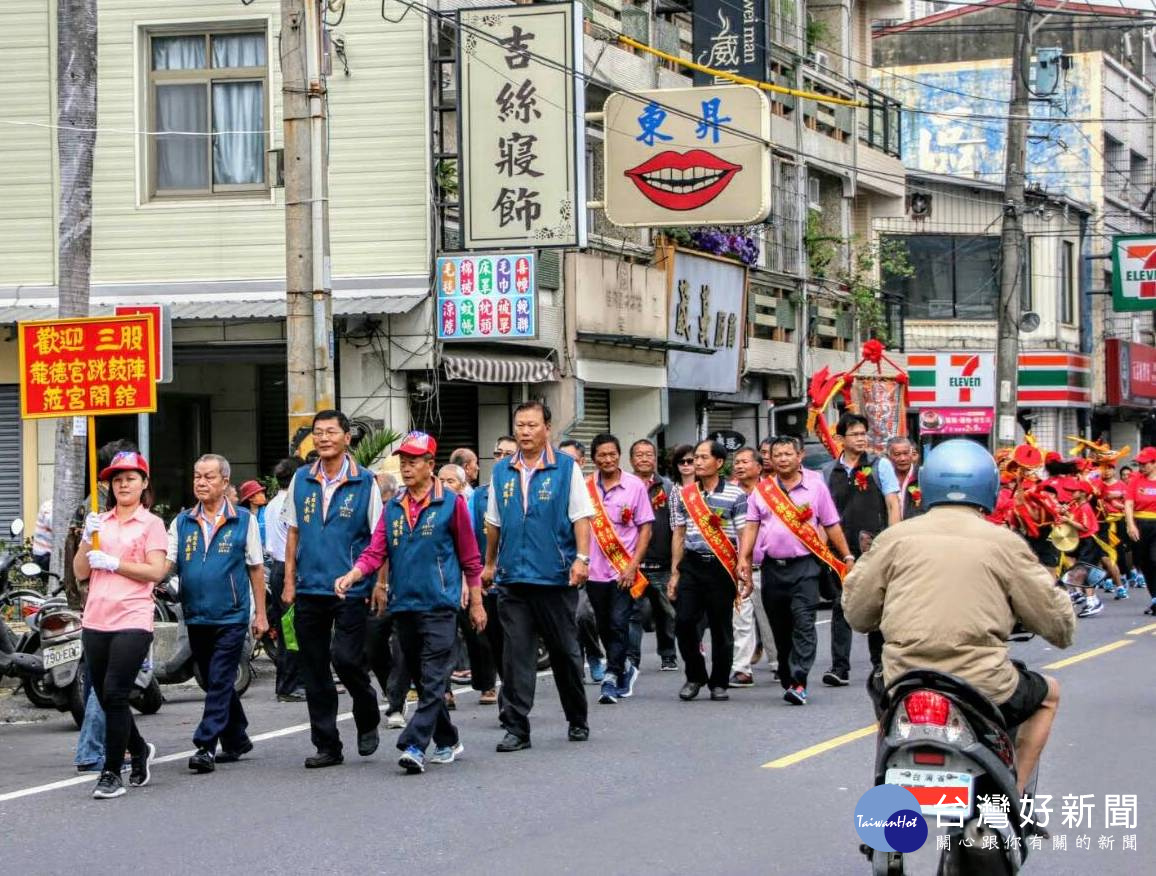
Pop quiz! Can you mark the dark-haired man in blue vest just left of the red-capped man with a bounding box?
[281,410,381,770]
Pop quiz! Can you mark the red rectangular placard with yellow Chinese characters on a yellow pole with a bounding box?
[20,314,156,420]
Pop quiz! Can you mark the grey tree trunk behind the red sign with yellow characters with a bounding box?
[52,0,97,600]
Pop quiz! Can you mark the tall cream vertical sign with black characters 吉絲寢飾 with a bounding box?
[458,3,586,250]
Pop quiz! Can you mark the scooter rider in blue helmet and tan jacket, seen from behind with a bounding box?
[843,439,1076,794]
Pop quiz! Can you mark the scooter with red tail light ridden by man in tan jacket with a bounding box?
[860,633,1044,876]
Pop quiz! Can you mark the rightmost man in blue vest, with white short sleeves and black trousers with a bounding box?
[482,401,594,751]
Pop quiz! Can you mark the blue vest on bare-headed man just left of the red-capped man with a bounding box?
[290,456,377,597]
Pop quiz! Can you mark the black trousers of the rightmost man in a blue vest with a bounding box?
[498,584,587,740]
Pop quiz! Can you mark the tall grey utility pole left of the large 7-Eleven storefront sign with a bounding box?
[994,0,1032,448]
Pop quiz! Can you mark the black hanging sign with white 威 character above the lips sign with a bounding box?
[691,0,766,86]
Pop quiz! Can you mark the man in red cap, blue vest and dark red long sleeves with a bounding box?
[334,432,486,773]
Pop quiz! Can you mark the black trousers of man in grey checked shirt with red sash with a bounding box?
[674,551,738,689]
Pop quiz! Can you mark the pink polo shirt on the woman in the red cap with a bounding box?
[83,507,169,632]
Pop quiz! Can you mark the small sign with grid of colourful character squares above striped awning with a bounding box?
[436,253,538,341]
